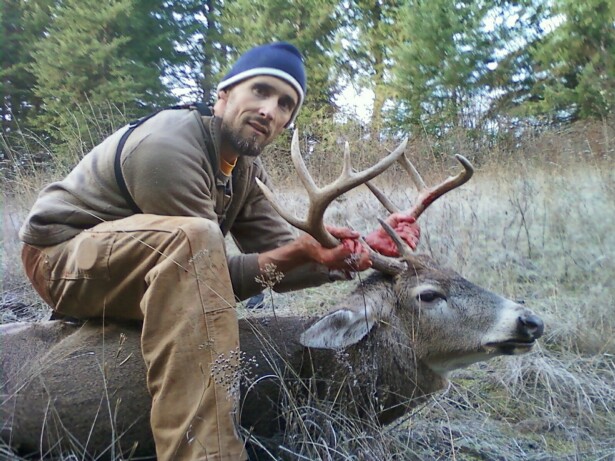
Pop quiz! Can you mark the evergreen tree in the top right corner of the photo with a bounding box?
[523,0,615,120]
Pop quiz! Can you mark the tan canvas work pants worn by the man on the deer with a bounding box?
[23,215,247,461]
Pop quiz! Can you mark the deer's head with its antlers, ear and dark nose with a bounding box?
[259,132,544,374]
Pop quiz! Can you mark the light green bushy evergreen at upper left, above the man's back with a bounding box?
[32,0,144,144]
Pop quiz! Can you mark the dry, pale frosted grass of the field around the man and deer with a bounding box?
[0,117,615,461]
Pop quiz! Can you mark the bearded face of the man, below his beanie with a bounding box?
[214,75,298,157]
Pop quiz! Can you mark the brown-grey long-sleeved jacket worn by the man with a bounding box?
[20,109,329,299]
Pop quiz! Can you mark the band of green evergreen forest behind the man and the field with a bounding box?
[0,0,615,160]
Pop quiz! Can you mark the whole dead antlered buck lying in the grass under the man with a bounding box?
[0,131,544,459]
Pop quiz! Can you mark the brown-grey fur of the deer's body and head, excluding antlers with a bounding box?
[0,261,542,455]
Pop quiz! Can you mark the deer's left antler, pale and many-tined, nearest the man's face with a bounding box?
[256,130,408,248]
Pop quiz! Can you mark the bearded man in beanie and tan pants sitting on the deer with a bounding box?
[20,43,418,460]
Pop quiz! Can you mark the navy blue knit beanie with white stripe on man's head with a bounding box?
[218,42,306,126]
